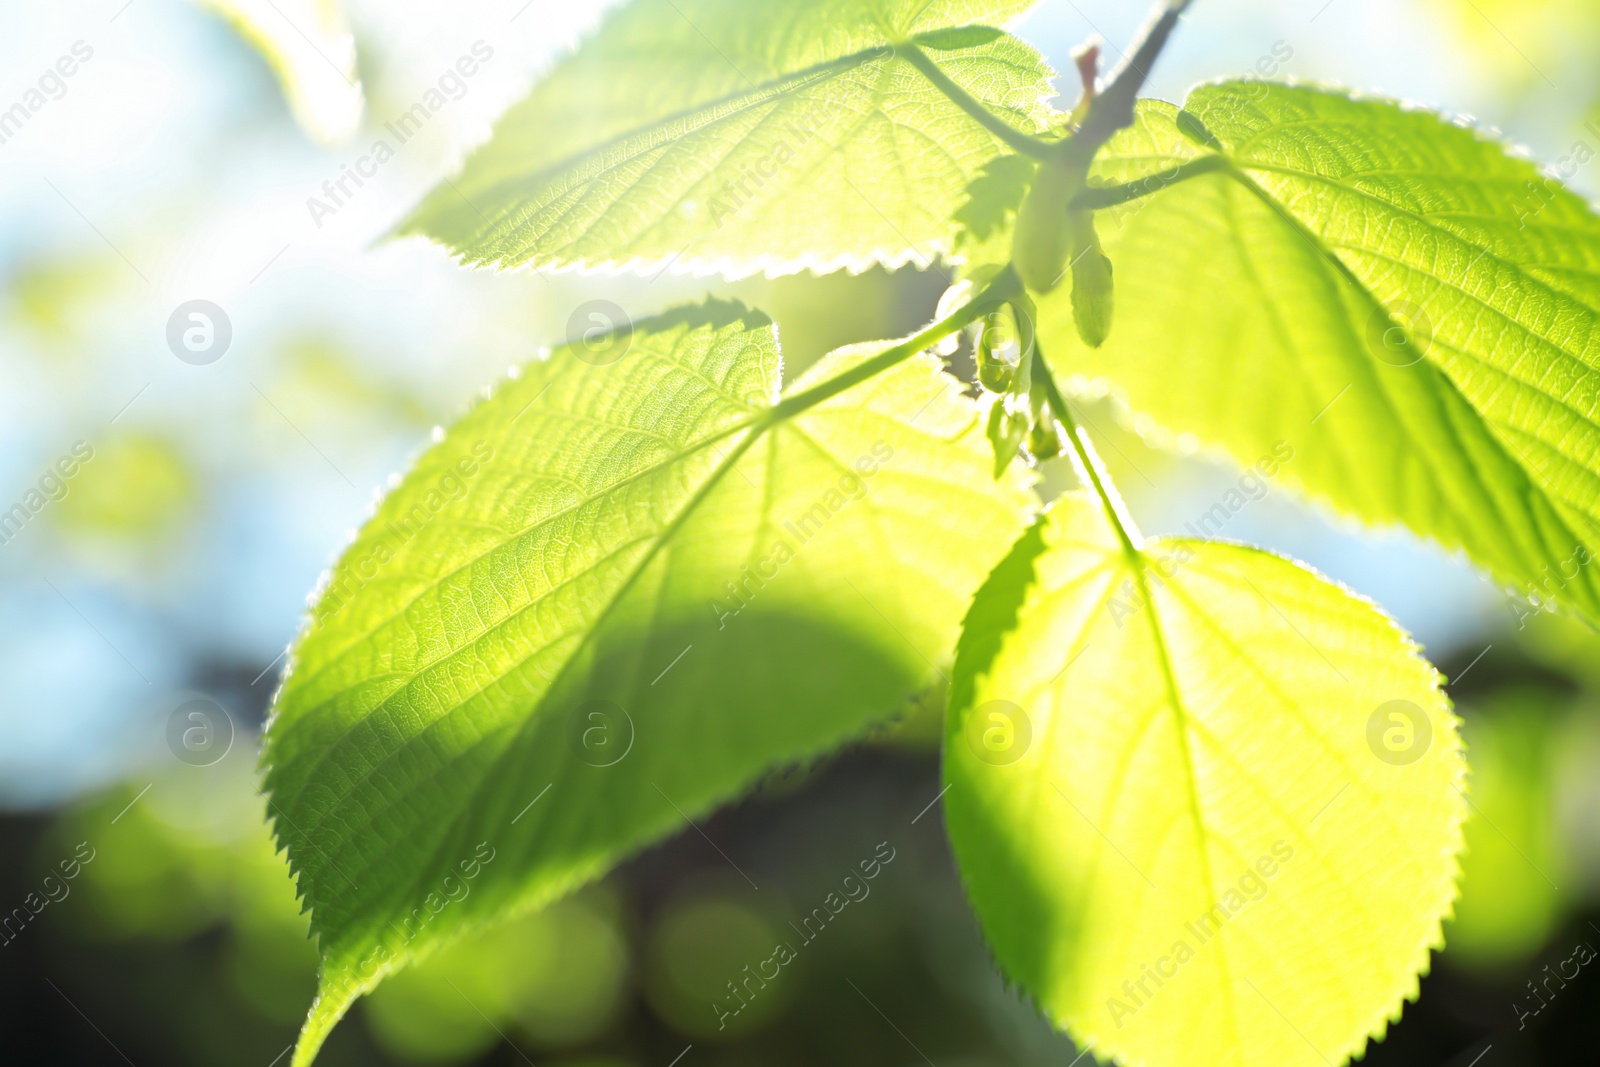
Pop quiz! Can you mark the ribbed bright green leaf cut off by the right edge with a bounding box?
[1040,82,1600,621]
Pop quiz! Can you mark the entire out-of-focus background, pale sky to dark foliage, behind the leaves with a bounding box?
[0,0,1600,1067]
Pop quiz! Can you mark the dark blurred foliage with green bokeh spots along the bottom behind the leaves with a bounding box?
[0,604,1600,1067]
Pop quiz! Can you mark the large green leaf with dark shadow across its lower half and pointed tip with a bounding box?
[264,304,1030,1064]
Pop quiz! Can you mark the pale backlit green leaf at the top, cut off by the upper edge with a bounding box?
[400,0,1053,275]
